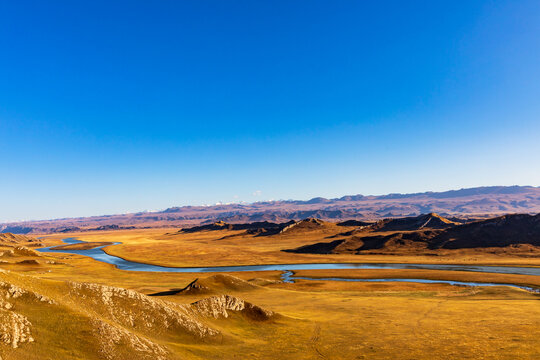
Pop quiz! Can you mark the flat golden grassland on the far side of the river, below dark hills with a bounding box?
[40,228,540,267]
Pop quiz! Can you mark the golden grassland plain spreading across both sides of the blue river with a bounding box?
[0,228,540,359]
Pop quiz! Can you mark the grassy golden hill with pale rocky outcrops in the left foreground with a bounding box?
[0,269,279,360]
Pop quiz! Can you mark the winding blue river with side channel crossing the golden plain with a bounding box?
[37,238,540,293]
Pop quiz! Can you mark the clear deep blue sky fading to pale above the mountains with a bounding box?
[0,0,540,221]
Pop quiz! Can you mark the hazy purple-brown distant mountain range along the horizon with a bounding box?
[0,186,540,234]
